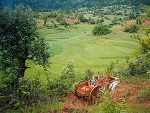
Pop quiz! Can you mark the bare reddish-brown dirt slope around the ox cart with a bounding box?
[63,78,150,113]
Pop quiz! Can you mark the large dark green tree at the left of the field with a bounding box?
[0,5,50,86]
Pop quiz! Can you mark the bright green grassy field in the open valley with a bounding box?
[26,21,140,80]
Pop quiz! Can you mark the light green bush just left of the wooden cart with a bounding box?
[49,60,76,96]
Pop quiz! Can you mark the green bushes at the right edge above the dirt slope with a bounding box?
[118,34,150,77]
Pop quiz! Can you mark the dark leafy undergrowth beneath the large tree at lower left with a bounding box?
[0,76,44,110]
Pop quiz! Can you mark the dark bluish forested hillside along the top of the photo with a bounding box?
[0,0,150,11]
